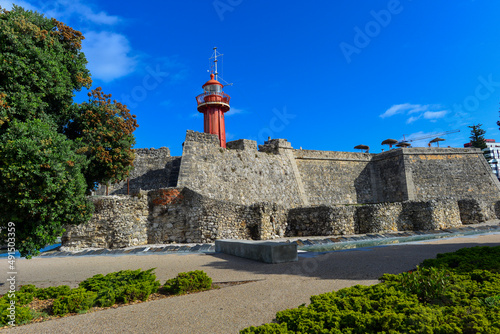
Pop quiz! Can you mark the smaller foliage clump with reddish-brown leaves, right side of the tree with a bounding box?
[65,88,137,189]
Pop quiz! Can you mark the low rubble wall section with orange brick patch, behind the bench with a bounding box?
[148,188,286,243]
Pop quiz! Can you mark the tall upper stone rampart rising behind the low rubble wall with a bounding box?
[178,131,500,208]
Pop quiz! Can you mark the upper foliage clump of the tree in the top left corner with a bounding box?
[0,6,92,131]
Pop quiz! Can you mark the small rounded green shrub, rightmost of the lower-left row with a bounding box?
[163,270,212,295]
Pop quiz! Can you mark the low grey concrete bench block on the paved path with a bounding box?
[215,240,298,263]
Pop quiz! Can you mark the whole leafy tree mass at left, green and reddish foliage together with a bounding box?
[0,6,138,257]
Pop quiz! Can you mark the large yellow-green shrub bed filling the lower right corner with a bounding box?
[241,247,500,334]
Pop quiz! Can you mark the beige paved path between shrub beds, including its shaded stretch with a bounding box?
[0,233,500,334]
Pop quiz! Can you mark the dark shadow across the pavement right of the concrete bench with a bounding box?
[200,237,500,280]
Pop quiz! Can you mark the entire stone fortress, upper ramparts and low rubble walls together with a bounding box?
[63,130,500,249]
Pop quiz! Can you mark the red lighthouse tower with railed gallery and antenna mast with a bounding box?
[196,48,231,148]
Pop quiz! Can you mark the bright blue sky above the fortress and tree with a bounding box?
[0,0,500,155]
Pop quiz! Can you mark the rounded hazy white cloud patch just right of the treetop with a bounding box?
[83,31,137,82]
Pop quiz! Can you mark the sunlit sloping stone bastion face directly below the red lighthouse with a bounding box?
[177,131,303,207]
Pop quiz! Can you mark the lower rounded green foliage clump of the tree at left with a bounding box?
[0,119,93,257]
